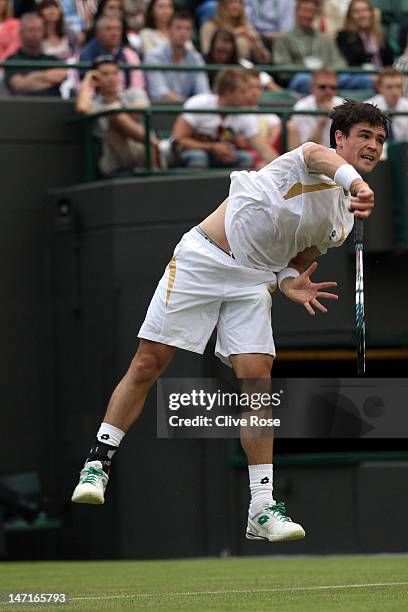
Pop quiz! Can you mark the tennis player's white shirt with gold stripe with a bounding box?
[225,142,354,272]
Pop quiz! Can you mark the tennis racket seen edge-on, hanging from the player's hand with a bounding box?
[354,219,366,376]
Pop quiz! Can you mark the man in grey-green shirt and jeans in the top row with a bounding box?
[274,0,345,93]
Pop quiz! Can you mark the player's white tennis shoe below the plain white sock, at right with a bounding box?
[246,502,305,542]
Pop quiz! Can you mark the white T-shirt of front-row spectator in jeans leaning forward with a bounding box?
[182,93,259,140]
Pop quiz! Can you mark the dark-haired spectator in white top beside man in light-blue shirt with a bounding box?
[140,0,174,55]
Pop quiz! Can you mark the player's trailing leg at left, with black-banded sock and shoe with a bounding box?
[71,340,175,504]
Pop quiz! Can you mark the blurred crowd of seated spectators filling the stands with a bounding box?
[0,0,408,176]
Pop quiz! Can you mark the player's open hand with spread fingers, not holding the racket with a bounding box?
[282,261,338,317]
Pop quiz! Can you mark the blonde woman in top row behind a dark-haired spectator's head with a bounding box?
[200,0,270,64]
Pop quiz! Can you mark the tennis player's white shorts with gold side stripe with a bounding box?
[138,227,276,365]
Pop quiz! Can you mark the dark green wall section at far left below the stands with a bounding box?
[0,97,82,516]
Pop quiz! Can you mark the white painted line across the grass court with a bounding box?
[69,582,408,601]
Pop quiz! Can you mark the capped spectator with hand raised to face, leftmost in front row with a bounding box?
[76,55,158,176]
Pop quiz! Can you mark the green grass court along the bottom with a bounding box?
[0,556,408,612]
